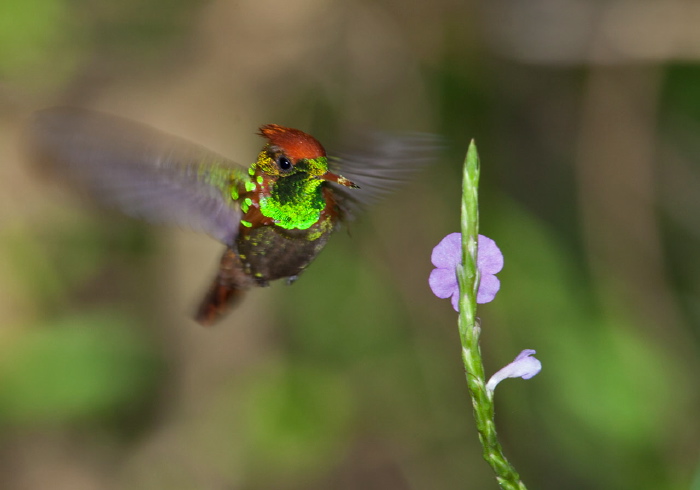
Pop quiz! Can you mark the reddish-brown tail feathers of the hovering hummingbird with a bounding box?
[194,248,253,327]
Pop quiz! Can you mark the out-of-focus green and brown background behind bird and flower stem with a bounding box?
[0,0,700,490]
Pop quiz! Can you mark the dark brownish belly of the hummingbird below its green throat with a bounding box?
[237,219,332,286]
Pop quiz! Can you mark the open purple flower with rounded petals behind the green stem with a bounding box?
[428,233,503,311]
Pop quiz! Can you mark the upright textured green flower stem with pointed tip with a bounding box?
[457,141,526,490]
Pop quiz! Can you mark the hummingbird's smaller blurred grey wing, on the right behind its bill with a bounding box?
[330,132,443,219]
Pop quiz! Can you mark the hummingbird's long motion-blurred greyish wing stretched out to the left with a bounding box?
[27,108,246,245]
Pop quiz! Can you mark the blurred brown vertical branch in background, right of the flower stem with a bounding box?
[576,66,687,348]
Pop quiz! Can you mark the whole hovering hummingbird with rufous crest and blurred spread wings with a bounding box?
[28,108,437,325]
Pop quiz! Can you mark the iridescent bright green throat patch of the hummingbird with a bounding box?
[260,158,327,230]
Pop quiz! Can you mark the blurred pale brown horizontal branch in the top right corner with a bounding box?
[486,0,700,65]
